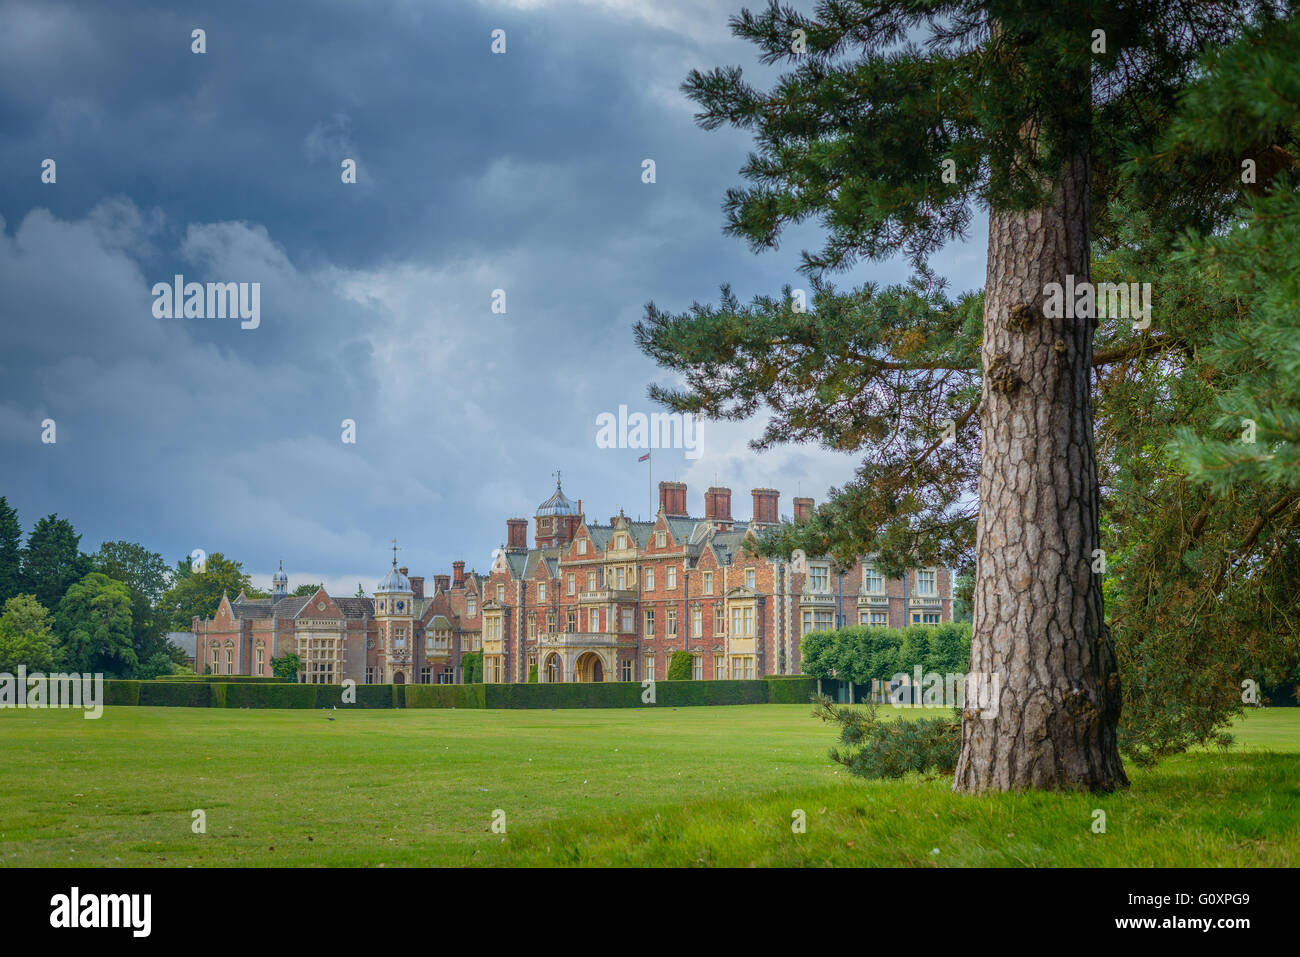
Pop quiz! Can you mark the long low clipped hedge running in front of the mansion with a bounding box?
[104,676,816,709]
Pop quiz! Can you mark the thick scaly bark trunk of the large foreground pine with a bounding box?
[953,159,1128,792]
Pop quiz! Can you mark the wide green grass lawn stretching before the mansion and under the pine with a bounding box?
[0,705,1300,867]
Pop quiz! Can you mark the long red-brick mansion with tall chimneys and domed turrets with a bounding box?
[192,482,953,684]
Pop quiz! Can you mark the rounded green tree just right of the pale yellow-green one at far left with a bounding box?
[55,572,139,675]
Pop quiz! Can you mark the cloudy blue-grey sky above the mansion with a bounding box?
[0,0,984,594]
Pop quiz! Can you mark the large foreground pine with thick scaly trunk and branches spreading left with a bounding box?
[637,0,1286,792]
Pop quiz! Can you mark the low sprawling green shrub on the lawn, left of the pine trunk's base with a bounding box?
[813,696,962,778]
